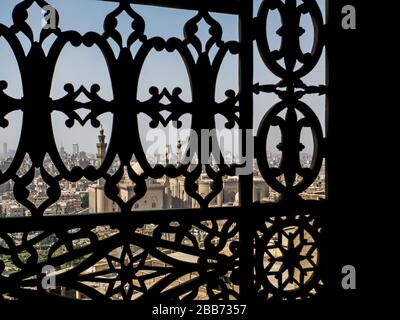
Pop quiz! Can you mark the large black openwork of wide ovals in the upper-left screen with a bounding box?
[0,1,239,216]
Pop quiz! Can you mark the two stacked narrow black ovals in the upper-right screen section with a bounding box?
[254,0,326,199]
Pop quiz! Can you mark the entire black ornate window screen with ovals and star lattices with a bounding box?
[0,0,326,301]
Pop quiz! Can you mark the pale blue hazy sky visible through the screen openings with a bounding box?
[0,0,325,158]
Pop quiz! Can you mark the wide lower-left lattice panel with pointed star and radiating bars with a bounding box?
[0,212,239,301]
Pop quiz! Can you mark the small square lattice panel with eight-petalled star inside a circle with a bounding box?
[255,211,322,300]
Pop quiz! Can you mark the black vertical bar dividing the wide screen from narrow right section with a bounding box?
[239,0,253,301]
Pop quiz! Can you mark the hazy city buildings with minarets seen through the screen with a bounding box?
[0,129,325,217]
